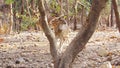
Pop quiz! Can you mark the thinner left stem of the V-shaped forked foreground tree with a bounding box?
[38,0,59,68]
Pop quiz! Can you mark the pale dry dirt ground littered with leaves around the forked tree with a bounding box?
[0,28,120,68]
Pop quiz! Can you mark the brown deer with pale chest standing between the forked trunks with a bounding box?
[50,18,70,51]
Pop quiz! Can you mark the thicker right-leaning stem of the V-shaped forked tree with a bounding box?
[58,0,107,68]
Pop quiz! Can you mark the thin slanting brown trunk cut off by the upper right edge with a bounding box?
[112,0,120,32]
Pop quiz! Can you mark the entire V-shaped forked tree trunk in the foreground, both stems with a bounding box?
[38,0,107,68]
